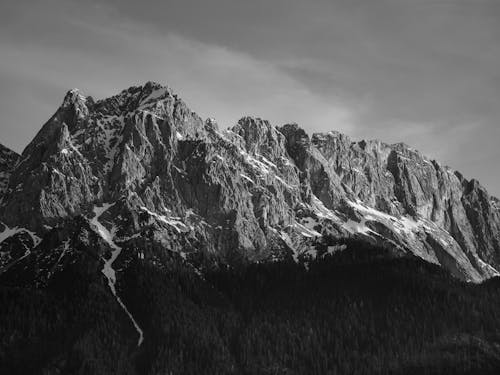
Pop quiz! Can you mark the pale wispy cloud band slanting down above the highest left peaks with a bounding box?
[0,0,350,150]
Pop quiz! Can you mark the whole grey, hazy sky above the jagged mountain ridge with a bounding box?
[0,0,500,196]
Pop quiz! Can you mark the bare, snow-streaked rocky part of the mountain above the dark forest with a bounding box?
[0,82,500,282]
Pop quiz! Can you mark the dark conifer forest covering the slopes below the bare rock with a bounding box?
[0,242,500,374]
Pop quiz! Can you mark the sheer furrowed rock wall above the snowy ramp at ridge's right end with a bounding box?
[313,132,500,280]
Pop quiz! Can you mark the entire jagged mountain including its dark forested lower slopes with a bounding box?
[0,82,500,374]
